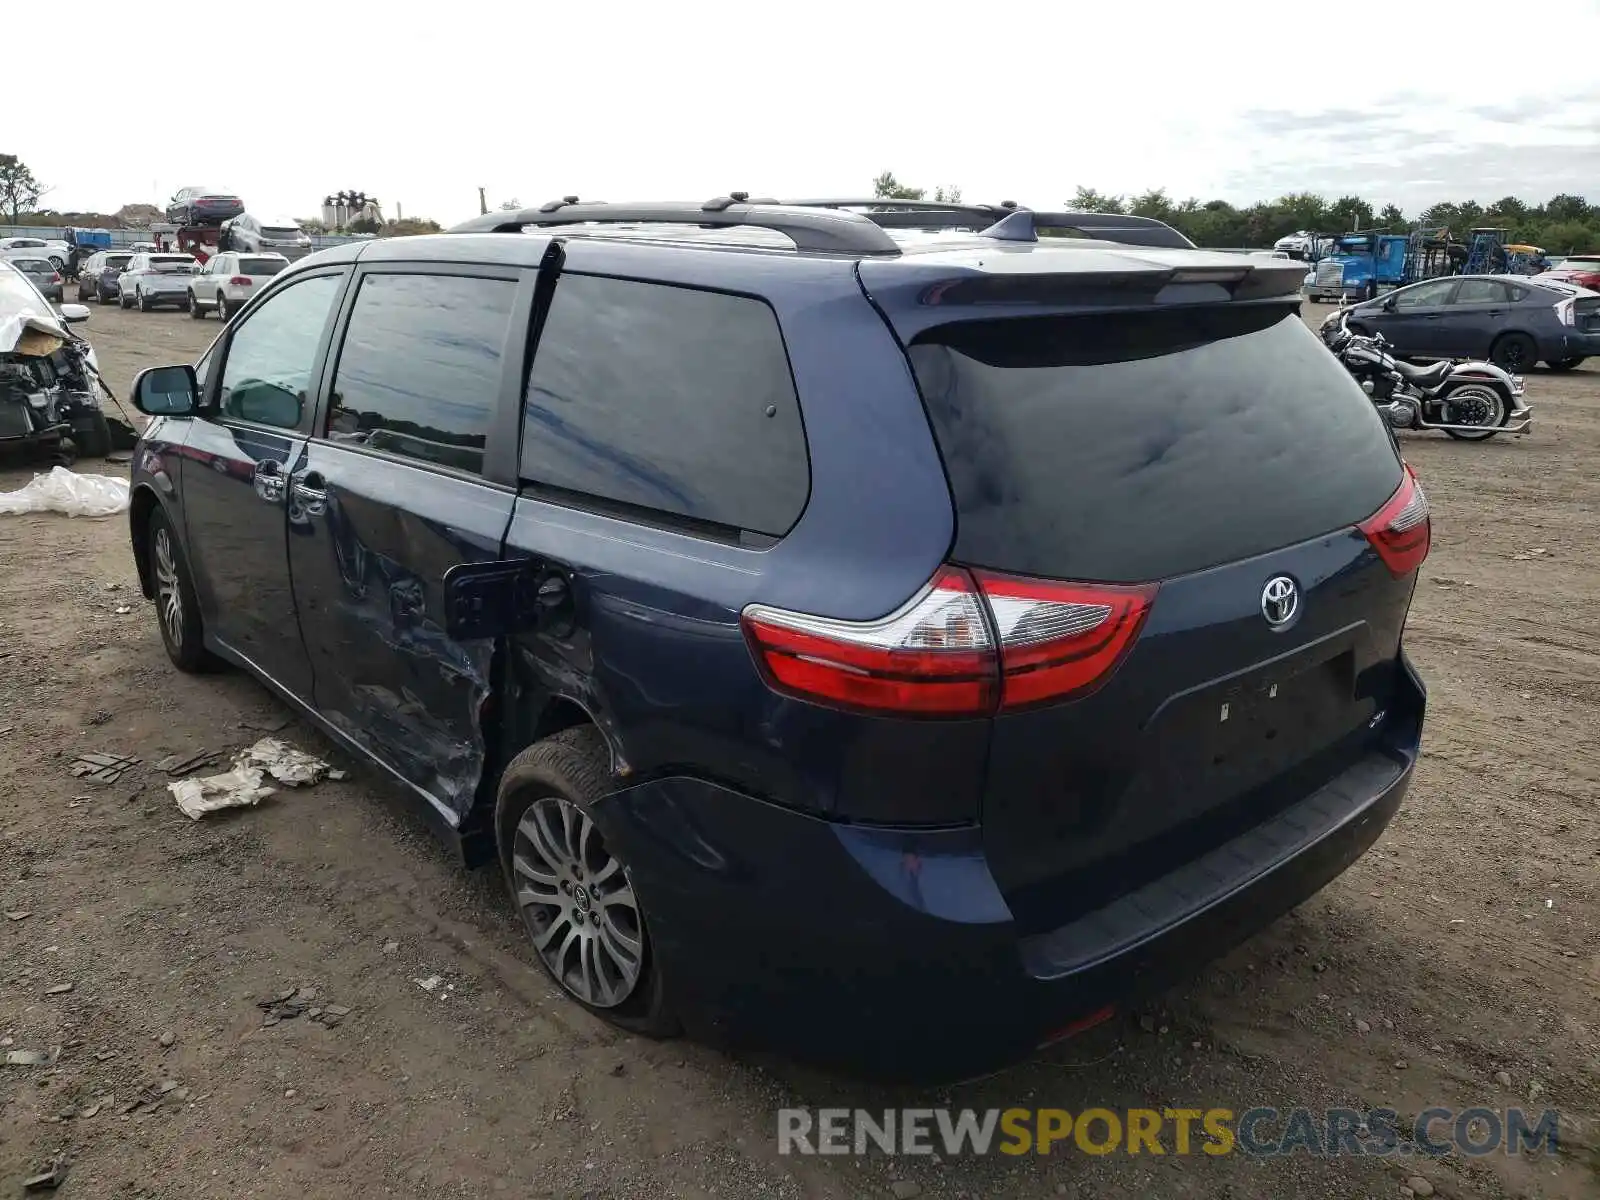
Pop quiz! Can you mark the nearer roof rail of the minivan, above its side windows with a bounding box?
[450,197,899,254]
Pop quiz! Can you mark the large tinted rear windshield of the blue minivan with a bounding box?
[910,306,1400,582]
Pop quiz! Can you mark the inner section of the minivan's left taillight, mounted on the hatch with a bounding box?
[978,571,1155,709]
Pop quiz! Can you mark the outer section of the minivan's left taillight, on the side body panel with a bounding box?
[742,566,998,717]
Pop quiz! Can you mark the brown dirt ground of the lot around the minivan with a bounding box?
[0,294,1600,1200]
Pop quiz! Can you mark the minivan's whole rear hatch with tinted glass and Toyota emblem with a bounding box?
[862,270,1427,931]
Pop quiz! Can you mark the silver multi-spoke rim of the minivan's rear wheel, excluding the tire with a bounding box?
[512,797,645,1008]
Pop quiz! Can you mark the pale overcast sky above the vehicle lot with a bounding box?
[15,0,1600,224]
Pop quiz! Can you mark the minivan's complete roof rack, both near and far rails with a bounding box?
[450,192,1194,254]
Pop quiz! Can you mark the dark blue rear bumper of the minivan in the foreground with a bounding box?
[600,667,1424,1080]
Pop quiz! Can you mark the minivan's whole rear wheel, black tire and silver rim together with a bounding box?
[494,725,678,1037]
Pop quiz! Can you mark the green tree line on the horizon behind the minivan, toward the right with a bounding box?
[872,171,1600,254]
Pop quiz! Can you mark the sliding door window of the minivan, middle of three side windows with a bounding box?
[328,275,517,474]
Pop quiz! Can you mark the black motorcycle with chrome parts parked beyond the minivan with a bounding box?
[1322,309,1533,442]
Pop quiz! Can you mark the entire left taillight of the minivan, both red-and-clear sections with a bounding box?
[742,566,1155,717]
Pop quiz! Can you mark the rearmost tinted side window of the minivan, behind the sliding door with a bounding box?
[522,275,810,536]
